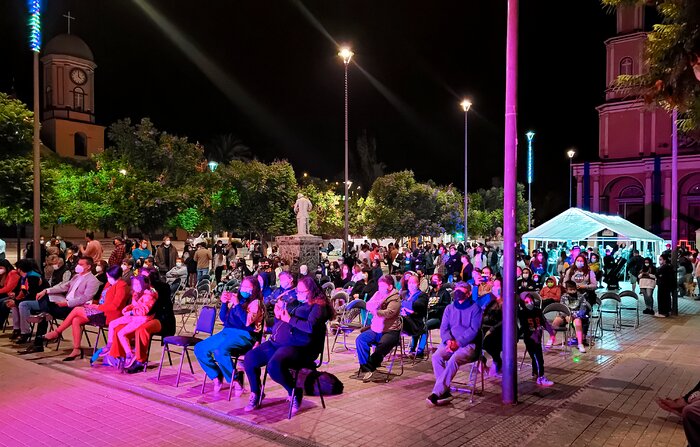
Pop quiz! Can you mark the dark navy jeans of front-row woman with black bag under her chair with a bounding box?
[243,341,315,396]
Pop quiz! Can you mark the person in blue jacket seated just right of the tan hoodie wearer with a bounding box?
[400,275,428,359]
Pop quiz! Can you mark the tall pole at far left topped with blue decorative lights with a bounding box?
[29,0,41,263]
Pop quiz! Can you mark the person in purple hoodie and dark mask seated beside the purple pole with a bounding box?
[427,289,482,406]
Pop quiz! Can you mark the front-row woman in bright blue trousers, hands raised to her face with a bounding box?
[194,276,265,395]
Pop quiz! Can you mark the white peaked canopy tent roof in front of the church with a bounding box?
[522,208,664,257]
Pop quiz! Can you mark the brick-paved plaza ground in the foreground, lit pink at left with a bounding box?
[0,282,700,447]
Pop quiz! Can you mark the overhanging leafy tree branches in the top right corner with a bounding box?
[602,0,700,132]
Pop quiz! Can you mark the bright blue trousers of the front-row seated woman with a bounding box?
[194,327,253,383]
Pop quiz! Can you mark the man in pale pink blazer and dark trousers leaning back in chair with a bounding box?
[19,257,101,354]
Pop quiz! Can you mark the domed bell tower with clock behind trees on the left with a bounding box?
[41,21,105,158]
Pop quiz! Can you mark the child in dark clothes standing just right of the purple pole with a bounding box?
[518,294,556,386]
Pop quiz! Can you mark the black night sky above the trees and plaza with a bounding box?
[0,0,615,222]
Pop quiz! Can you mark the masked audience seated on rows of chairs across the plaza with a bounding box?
[0,233,680,412]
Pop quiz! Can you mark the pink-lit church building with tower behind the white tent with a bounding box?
[573,6,700,245]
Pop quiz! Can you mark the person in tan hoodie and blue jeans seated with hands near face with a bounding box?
[355,275,401,382]
